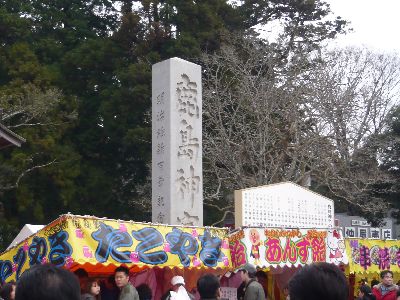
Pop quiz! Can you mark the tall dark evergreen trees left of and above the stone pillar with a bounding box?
[0,0,346,248]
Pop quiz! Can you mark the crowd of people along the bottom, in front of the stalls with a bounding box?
[0,263,400,300]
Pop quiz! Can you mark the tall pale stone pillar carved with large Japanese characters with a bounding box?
[152,57,203,226]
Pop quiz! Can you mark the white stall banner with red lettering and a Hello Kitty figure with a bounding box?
[229,228,348,268]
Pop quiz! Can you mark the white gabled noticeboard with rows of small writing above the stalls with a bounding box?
[235,182,334,228]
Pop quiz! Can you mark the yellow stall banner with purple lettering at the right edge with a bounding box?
[346,239,400,274]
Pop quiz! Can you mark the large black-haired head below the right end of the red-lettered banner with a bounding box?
[289,262,349,300]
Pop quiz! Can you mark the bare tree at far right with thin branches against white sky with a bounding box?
[309,49,400,220]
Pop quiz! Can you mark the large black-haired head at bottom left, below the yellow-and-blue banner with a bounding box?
[15,264,81,300]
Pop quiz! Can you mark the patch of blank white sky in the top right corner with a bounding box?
[326,0,400,52]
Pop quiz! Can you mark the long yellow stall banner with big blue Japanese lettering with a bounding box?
[0,215,231,281]
